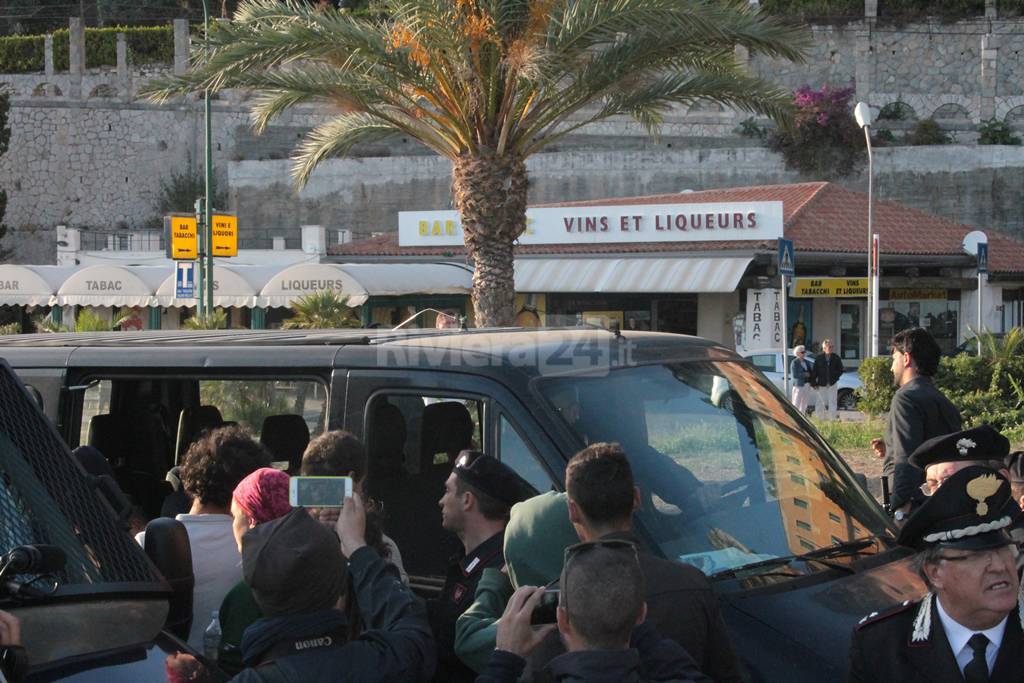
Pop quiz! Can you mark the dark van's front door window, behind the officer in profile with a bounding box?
[366,393,483,577]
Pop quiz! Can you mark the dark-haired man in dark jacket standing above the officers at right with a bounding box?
[871,328,961,524]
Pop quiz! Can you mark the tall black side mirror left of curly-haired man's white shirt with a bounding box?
[144,517,196,640]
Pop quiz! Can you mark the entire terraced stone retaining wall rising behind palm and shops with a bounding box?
[0,16,1024,262]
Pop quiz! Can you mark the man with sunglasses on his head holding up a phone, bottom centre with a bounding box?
[476,541,710,683]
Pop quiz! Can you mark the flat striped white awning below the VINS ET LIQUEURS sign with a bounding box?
[515,256,754,294]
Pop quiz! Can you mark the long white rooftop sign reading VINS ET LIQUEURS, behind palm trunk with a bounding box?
[398,202,782,247]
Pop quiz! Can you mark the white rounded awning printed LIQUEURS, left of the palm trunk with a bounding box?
[257,263,473,307]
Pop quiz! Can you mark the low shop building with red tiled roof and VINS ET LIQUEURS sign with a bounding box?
[328,182,1024,366]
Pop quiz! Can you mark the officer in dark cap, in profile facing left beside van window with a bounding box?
[427,451,532,682]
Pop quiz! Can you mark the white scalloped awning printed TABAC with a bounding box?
[50,265,167,306]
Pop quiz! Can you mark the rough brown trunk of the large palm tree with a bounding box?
[452,151,528,327]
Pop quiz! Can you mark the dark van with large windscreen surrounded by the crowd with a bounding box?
[0,328,925,683]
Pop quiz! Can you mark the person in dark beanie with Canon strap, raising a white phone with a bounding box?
[231,495,435,683]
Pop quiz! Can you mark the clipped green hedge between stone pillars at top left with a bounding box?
[0,25,174,74]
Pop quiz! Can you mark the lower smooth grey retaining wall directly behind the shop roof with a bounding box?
[228,145,1024,249]
